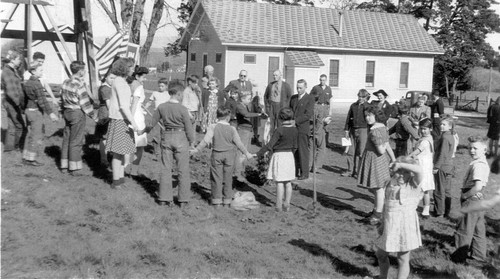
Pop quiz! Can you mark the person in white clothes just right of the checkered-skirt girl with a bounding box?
[130,67,149,176]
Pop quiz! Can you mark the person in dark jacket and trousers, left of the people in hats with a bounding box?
[341,89,370,178]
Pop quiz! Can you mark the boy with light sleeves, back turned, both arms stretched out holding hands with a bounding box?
[191,108,253,208]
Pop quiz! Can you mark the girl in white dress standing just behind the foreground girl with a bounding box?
[410,118,435,218]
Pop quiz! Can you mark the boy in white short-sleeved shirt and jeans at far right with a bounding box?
[451,136,490,262]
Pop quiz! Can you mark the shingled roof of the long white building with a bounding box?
[193,0,443,54]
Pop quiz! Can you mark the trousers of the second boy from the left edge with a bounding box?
[23,109,44,161]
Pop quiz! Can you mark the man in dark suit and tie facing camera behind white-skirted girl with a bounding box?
[290,79,315,180]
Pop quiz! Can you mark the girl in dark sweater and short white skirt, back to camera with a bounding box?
[257,108,298,212]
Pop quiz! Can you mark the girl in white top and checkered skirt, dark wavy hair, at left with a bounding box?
[106,58,138,188]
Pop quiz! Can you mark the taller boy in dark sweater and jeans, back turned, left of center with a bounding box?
[144,83,195,208]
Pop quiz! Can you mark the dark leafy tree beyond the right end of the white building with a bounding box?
[430,0,500,95]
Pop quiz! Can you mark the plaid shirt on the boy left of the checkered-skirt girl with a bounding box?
[61,76,95,118]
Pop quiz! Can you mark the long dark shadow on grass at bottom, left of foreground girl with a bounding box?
[288,239,370,277]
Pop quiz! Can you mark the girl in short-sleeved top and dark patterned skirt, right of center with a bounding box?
[358,106,395,225]
